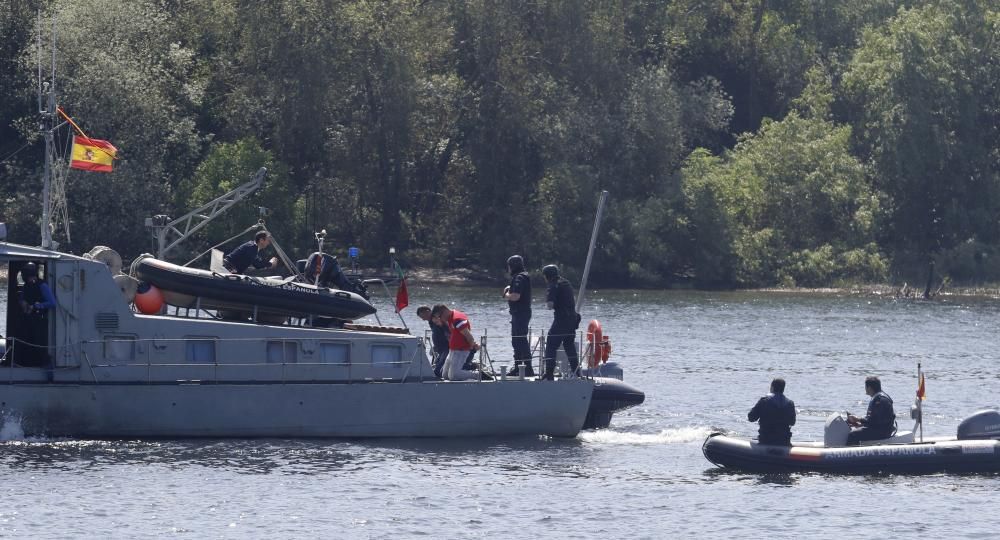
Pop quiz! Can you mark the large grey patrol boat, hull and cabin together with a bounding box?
[0,242,595,437]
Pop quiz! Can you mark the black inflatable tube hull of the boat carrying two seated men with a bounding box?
[702,434,1000,474]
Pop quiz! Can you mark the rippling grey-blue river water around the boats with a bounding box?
[0,284,1000,539]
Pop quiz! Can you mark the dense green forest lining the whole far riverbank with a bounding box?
[0,0,1000,288]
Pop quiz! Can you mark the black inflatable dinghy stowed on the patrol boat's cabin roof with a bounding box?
[132,255,375,321]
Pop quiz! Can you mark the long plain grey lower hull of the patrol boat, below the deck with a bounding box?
[0,380,593,438]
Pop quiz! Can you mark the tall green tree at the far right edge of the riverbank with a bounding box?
[843,0,1000,266]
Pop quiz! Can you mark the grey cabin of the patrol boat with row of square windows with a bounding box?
[0,242,434,384]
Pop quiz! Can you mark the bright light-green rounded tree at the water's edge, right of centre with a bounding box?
[683,113,884,286]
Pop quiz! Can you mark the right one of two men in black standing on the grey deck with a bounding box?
[539,264,580,381]
